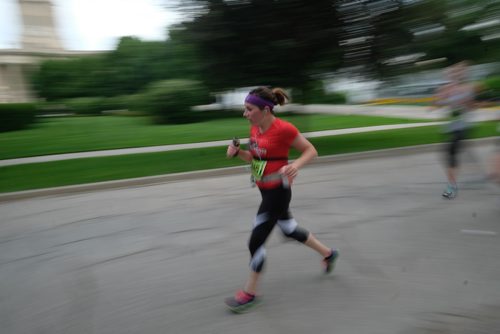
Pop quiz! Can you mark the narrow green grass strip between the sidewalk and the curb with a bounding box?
[0,122,497,192]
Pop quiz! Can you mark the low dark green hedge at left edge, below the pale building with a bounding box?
[0,103,37,132]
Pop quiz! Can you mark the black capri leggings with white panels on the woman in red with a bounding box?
[248,187,309,272]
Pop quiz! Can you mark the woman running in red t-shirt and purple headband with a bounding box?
[226,87,339,312]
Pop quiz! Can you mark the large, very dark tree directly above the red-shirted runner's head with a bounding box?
[174,0,338,94]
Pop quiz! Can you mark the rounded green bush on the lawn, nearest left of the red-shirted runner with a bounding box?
[140,79,211,124]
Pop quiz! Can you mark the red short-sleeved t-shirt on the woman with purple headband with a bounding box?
[249,118,299,189]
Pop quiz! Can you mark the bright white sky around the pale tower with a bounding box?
[0,0,181,50]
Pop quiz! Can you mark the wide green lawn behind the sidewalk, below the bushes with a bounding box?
[0,114,434,159]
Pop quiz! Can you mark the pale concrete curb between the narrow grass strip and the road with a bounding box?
[0,137,498,203]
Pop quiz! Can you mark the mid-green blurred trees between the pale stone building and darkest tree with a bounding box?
[33,32,200,100]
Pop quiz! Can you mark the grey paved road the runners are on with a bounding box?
[0,145,500,334]
